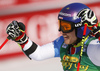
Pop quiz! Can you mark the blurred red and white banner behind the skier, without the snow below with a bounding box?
[0,0,100,57]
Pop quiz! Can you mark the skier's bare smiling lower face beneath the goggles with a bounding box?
[60,29,77,44]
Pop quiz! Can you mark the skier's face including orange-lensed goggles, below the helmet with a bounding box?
[59,20,77,44]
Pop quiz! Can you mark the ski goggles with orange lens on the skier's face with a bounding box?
[59,20,74,33]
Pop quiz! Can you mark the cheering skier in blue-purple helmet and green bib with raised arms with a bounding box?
[6,3,100,71]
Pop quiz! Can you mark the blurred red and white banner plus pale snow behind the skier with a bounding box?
[0,0,100,71]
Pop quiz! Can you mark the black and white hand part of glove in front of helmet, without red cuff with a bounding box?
[78,9,98,27]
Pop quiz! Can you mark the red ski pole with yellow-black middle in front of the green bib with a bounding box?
[77,23,87,71]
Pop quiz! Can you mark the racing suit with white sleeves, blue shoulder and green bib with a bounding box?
[20,36,100,71]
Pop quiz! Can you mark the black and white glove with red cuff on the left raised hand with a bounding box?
[6,21,28,44]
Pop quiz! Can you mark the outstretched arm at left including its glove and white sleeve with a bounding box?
[6,21,59,60]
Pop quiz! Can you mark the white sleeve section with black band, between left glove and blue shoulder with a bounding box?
[21,39,55,60]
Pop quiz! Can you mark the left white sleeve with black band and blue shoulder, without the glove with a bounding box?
[21,36,64,60]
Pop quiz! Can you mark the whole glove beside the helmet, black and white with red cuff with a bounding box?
[78,9,100,38]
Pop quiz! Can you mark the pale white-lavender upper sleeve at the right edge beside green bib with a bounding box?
[87,39,100,66]
